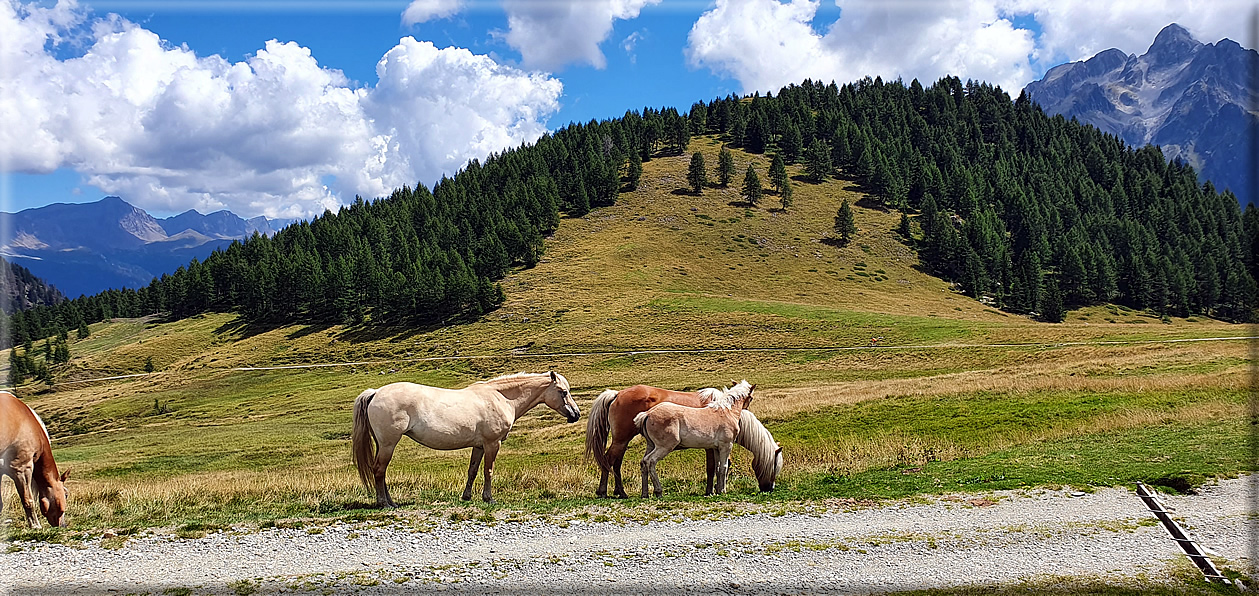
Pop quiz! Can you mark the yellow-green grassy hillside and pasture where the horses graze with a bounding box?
[4,137,1249,529]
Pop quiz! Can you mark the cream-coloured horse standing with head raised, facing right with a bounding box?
[350,372,582,507]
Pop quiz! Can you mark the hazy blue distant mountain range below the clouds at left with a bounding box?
[0,197,292,297]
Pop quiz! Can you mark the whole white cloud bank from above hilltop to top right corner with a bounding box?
[686,0,1249,93]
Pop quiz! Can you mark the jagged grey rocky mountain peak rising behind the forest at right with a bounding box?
[1025,23,1259,204]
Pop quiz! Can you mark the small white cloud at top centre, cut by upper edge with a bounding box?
[502,0,660,71]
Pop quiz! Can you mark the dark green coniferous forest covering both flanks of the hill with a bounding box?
[0,77,1259,344]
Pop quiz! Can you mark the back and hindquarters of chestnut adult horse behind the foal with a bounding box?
[585,384,721,499]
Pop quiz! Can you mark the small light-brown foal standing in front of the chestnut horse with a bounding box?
[633,381,757,498]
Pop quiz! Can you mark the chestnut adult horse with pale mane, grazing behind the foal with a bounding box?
[585,384,783,499]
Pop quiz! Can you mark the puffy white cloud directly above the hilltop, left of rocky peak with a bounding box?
[686,0,1032,91]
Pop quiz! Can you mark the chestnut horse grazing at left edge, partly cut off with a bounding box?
[0,391,71,528]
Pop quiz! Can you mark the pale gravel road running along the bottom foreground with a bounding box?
[0,478,1259,595]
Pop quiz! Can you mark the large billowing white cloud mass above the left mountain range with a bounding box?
[0,0,562,217]
